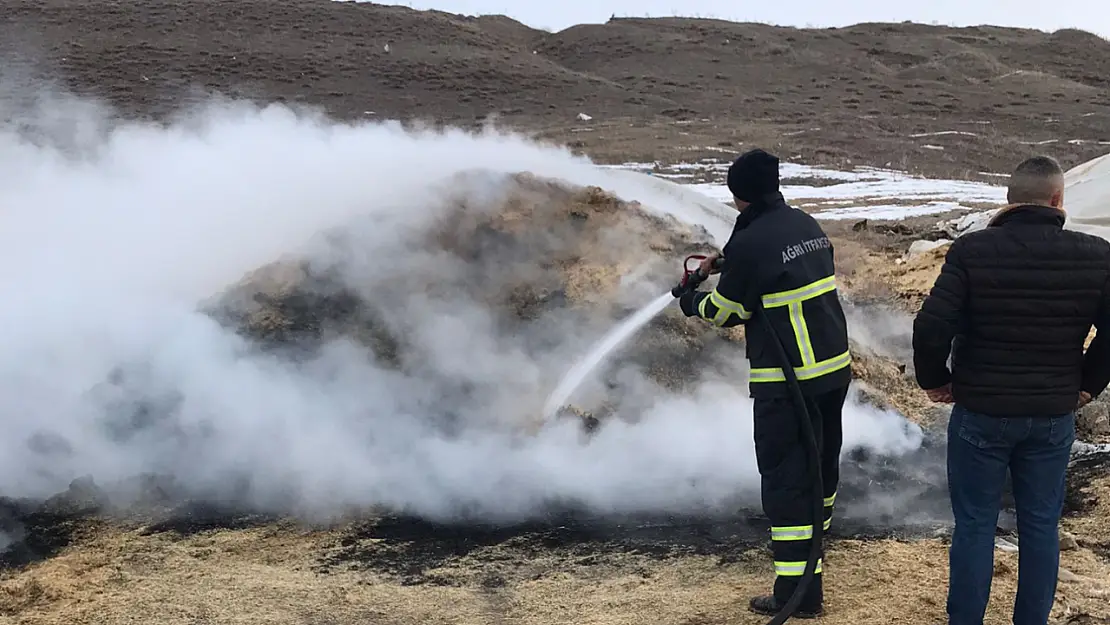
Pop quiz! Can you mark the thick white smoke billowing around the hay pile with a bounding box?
[0,86,917,518]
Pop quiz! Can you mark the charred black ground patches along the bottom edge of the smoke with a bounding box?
[0,438,1110,584]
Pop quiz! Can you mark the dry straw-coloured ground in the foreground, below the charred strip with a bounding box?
[0,512,1110,625]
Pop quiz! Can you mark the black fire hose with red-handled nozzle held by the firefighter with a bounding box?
[670,254,825,625]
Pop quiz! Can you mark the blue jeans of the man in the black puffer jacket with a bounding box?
[948,404,1076,625]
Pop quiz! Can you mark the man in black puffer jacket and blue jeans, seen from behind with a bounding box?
[914,157,1110,625]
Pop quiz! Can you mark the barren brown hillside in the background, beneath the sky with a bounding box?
[0,0,1110,177]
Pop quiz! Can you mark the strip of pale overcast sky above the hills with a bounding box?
[377,0,1110,37]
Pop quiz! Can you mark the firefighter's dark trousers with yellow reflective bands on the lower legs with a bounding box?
[754,386,848,609]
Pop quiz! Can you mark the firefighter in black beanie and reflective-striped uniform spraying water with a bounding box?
[679,150,851,618]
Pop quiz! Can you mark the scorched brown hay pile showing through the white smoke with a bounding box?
[209,174,743,413]
